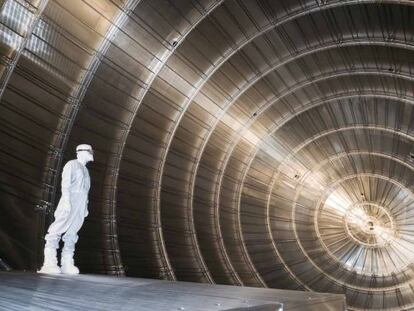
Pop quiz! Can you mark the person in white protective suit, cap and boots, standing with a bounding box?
[39,144,94,274]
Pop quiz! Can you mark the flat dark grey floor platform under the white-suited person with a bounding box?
[0,272,345,311]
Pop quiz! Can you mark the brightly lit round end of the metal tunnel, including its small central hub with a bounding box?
[314,179,414,277]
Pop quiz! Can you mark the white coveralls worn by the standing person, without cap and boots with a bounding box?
[45,159,91,254]
